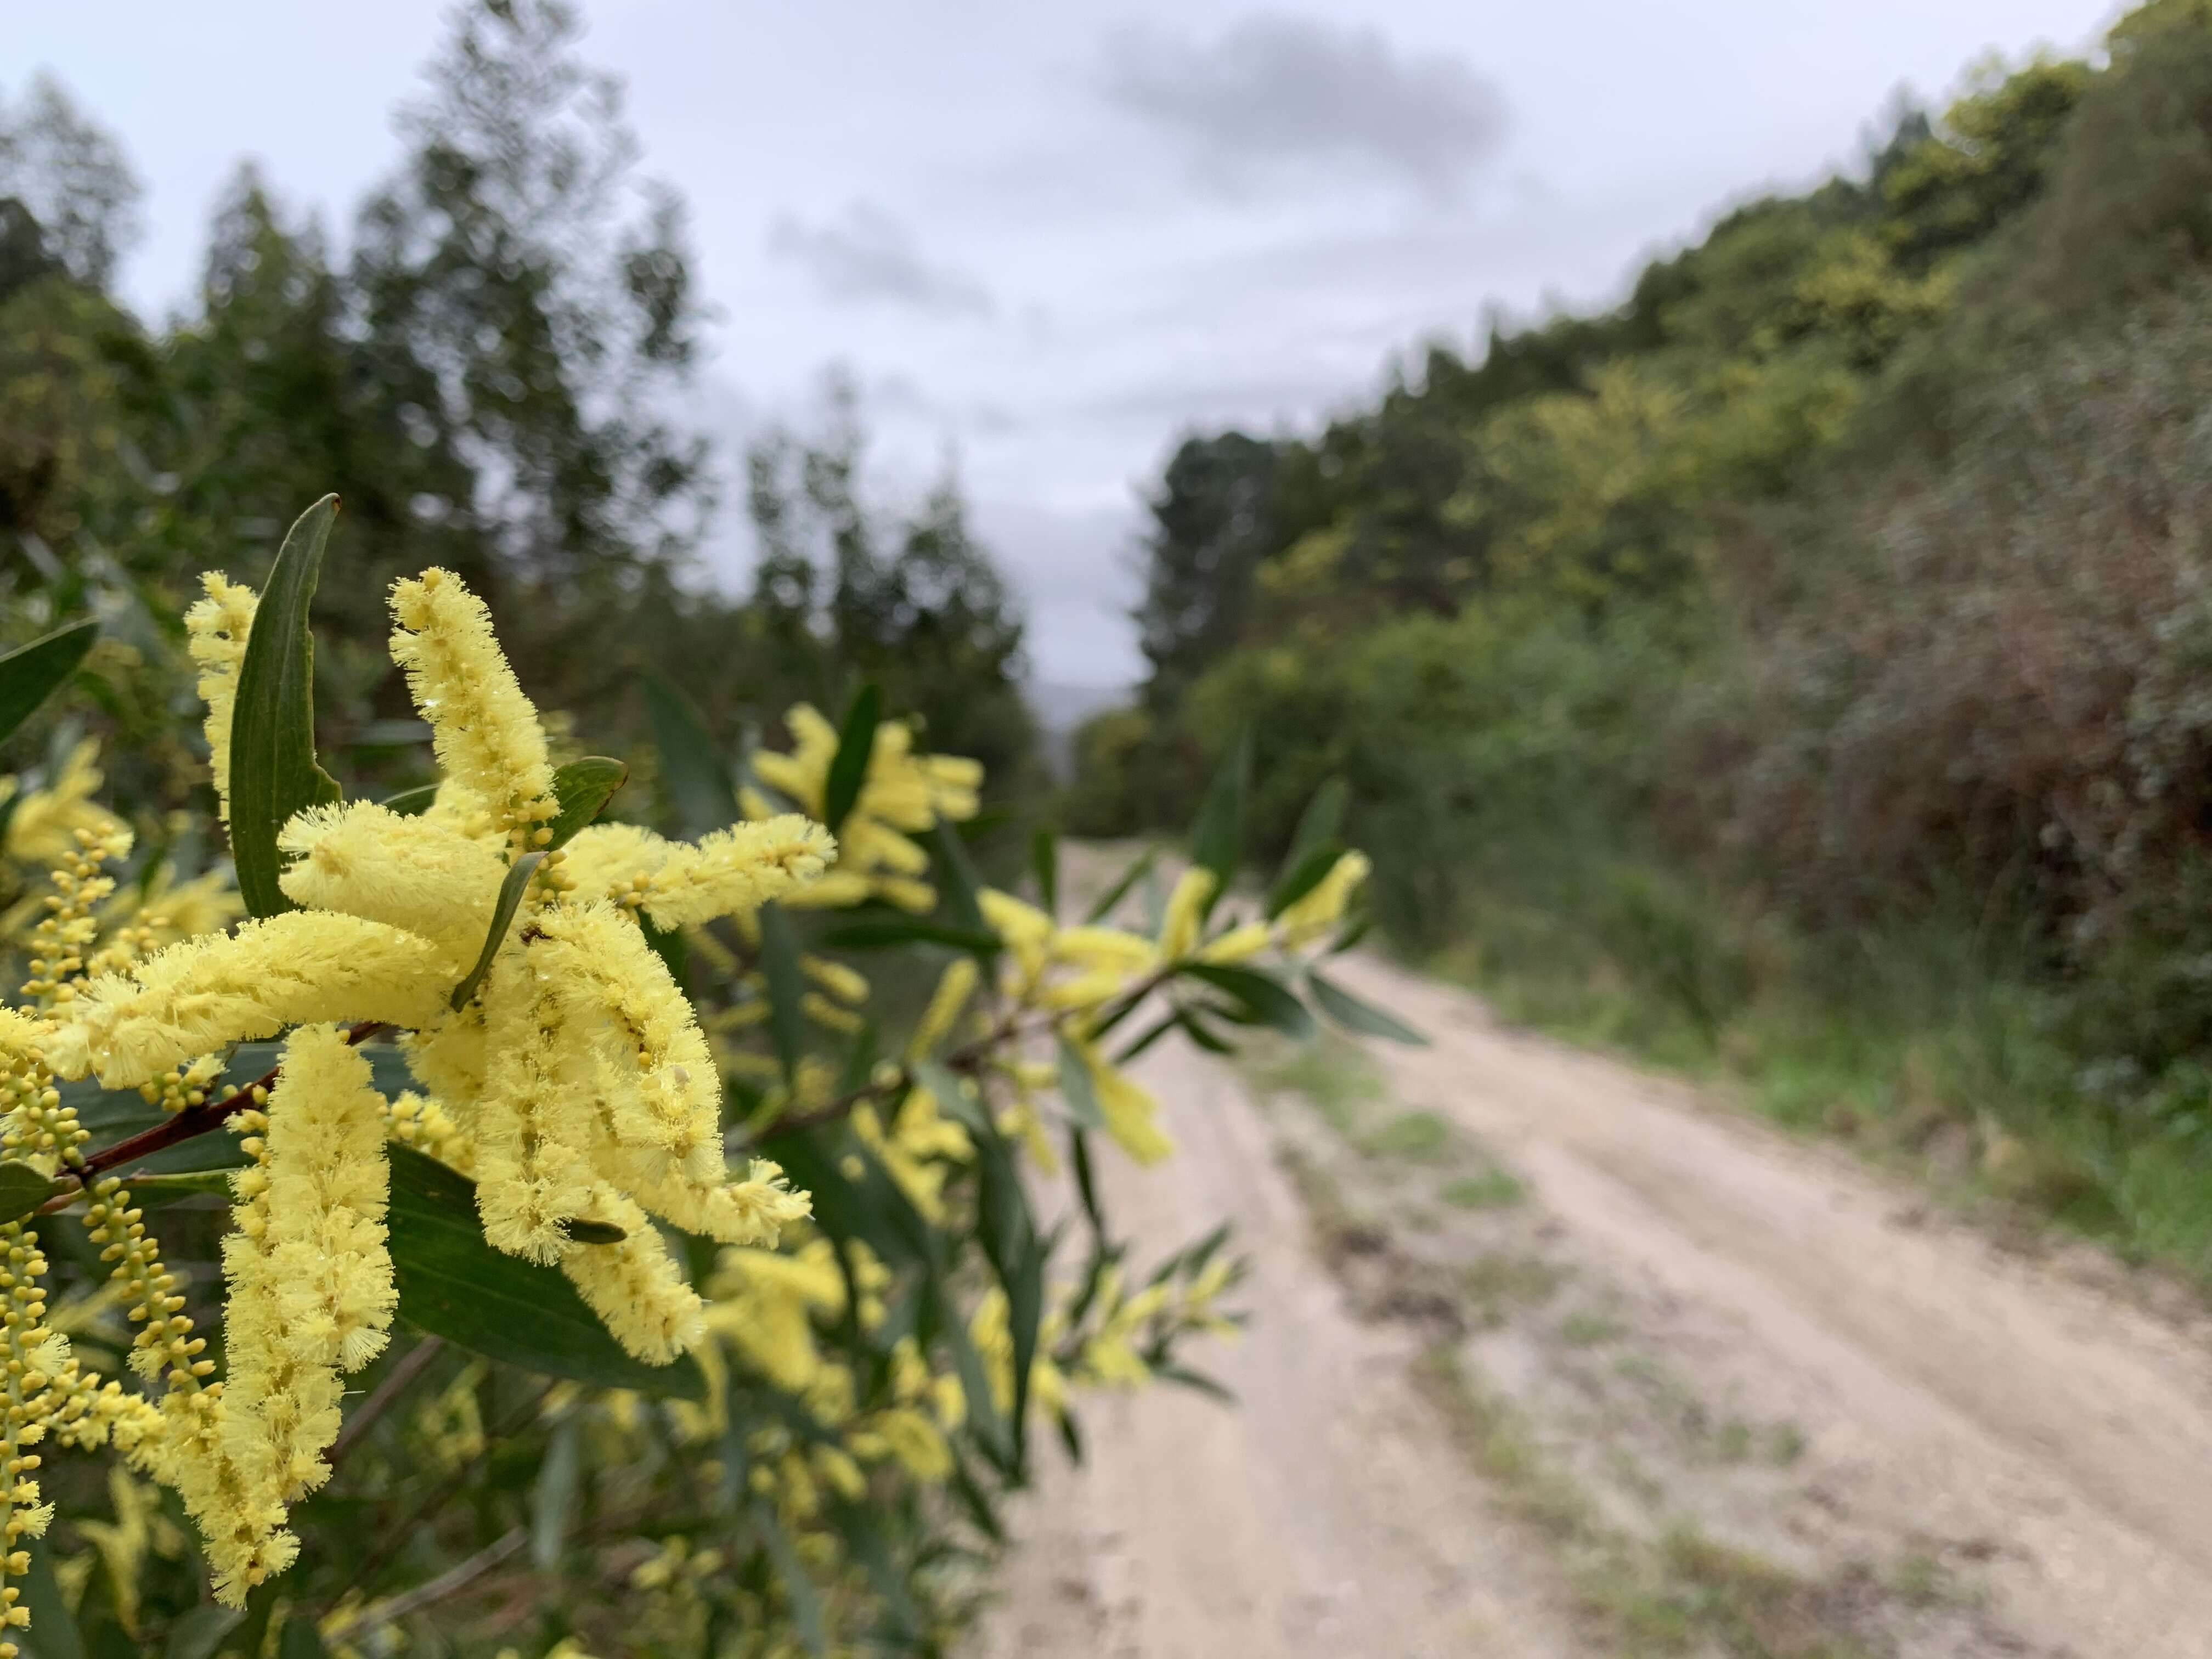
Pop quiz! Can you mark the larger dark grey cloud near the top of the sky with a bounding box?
[1102,13,1506,197]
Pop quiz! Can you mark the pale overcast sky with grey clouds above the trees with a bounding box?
[13,0,2113,686]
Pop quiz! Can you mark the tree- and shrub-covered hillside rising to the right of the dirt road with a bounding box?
[1068,0,2212,1276]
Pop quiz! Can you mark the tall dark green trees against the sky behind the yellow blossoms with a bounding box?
[0,2,1031,818]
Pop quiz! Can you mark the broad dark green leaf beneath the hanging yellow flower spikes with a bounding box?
[385,1144,706,1400]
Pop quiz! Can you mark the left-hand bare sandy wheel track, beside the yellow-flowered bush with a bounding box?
[984,1046,1579,1659]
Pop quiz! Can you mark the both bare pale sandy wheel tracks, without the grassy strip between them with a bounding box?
[978,898,2212,1659]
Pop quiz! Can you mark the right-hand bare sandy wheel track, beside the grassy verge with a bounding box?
[1345,962,2212,1659]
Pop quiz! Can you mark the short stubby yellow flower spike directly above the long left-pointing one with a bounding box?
[276,801,506,978]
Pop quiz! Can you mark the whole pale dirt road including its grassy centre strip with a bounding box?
[982,938,2212,1659]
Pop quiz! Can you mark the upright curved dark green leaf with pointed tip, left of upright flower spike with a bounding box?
[230,495,341,916]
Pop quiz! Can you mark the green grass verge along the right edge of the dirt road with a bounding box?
[1427,885,2212,1290]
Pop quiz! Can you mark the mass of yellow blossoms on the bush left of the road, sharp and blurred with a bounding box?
[0,535,1369,1659]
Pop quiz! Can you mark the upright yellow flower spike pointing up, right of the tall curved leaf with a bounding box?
[392,568,560,849]
